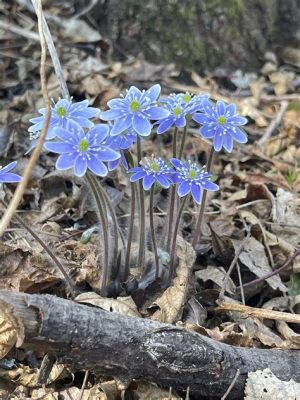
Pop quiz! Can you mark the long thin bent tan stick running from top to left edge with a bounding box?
[0,0,51,237]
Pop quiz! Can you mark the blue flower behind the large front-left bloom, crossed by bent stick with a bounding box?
[28,99,99,140]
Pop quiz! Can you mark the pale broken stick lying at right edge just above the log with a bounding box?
[214,302,300,324]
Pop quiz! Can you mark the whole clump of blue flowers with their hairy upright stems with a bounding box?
[24,84,248,289]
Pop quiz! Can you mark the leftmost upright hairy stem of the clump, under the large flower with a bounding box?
[86,172,109,291]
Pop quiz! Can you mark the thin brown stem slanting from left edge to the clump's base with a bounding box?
[0,199,76,298]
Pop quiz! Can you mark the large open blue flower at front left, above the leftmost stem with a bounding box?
[45,120,120,177]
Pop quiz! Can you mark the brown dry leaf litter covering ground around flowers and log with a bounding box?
[0,3,300,400]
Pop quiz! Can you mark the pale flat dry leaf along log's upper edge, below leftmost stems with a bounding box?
[75,292,141,317]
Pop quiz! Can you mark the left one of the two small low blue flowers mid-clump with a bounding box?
[128,156,174,190]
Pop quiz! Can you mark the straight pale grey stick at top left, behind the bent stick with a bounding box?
[31,0,70,99]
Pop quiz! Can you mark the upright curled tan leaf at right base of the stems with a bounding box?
[151,238,195,324]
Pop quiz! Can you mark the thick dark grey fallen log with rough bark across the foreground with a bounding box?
[0,290,300,399]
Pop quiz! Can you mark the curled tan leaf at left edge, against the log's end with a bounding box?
[0,300,24,359]
